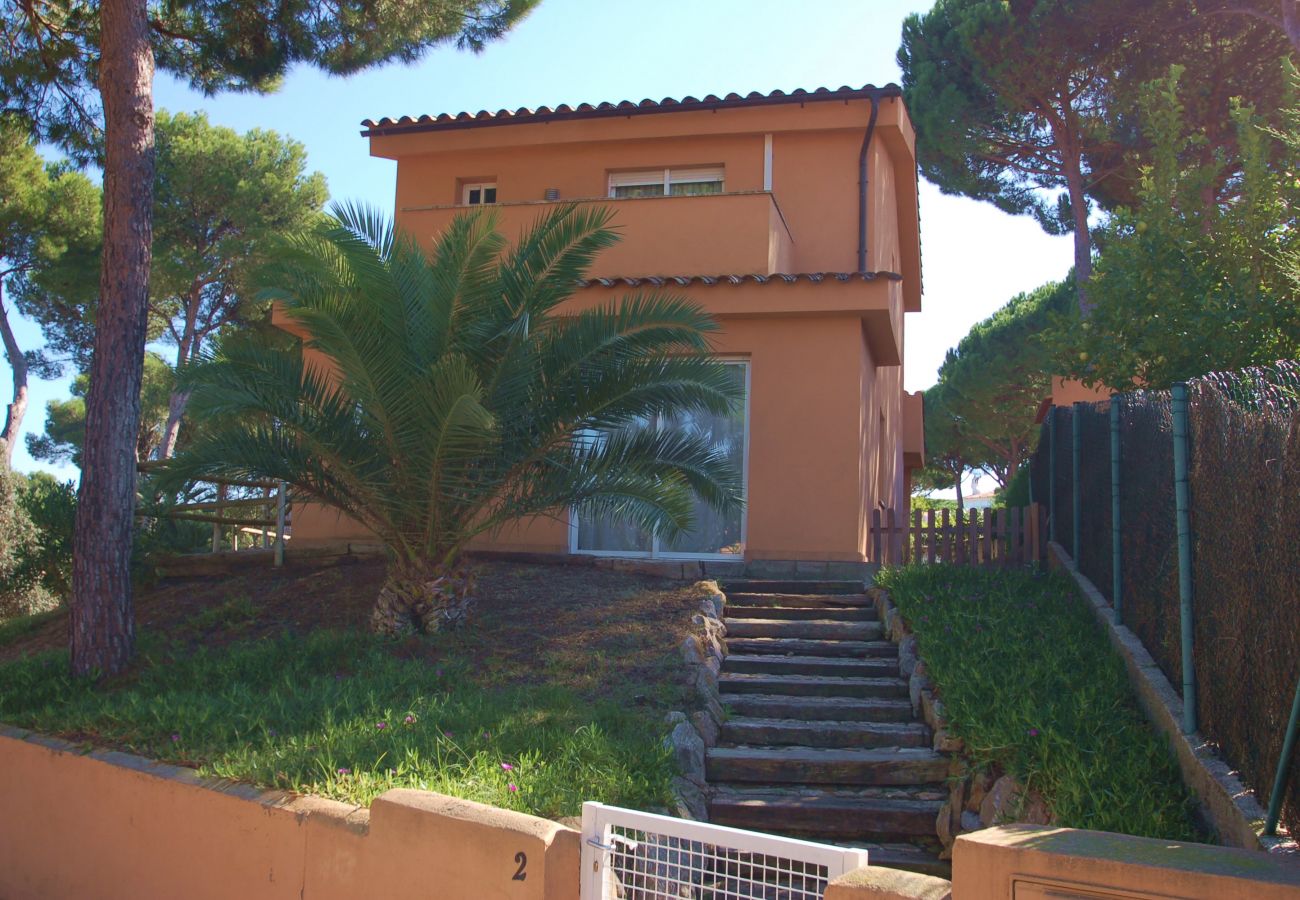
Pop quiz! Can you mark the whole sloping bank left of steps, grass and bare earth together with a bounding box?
[0,563,702,818]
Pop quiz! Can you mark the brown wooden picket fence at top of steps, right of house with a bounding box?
[871,503,1045,566]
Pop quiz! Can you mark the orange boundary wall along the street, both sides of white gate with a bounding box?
[0,726,1300,900]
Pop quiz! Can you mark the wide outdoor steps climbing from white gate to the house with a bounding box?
[706,581,949,874]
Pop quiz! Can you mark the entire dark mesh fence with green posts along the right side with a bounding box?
[1030,362,1300,835]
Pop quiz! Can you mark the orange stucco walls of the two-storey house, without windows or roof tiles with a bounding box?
[286,89,920,562]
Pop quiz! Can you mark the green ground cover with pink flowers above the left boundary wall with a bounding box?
[0,631,672,818]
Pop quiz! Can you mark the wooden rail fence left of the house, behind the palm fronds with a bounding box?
[137,460,291,566]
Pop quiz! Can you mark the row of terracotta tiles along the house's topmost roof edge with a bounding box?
[361,85,902,137]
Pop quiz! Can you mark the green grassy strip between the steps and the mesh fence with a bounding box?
[876,566,1201,840]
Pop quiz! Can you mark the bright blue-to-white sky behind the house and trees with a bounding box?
[7,0,1073,477]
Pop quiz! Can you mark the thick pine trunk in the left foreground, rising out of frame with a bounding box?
[70,0,153,675]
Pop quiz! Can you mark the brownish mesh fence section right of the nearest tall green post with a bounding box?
[1188,363,1300,835]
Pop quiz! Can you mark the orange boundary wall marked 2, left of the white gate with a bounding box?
[0,726,580,900]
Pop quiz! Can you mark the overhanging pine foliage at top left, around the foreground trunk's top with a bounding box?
[0,0,538,159]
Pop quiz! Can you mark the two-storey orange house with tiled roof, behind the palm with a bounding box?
[282,86,922,572]
